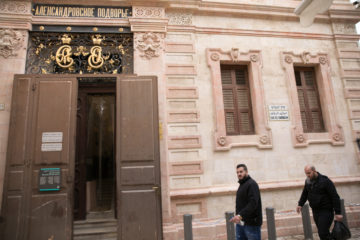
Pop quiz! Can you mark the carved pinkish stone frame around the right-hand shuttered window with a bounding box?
[280,52,345,147]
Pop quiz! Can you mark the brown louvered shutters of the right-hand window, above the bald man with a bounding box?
[295,68,325,132]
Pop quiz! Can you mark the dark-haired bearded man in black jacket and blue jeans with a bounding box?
[230,164,262,240]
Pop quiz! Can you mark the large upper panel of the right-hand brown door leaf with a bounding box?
[120,78,157,162]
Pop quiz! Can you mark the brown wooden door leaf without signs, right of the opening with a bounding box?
[116,77,162,240]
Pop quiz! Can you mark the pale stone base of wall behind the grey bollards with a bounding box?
[164,206,360,240]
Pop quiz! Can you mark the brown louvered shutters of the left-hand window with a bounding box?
[221,65,255,135]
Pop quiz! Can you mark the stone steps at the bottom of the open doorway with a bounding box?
[73,218,117,240]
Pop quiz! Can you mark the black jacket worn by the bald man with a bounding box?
[299,173,341,214]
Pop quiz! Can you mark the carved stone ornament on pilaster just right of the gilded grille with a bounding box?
[135,32,165,60]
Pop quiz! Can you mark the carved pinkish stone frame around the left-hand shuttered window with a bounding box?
[206,48,272,150]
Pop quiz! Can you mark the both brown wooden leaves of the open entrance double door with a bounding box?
[0,75,162,240]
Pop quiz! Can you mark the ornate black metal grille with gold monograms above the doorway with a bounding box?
[26,32,133,74]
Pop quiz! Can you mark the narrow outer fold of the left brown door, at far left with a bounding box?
[0,76,33,240]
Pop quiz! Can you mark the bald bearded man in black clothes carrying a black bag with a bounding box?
[296,165,343,240]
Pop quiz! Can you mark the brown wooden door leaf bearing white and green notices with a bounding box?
[3,75,77,240]
